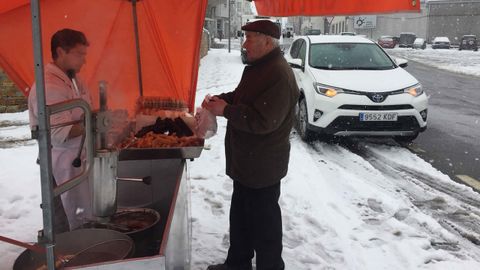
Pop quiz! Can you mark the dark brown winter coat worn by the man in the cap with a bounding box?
[219,48,299,188]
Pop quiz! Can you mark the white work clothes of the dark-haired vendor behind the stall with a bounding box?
[28,63,91,229]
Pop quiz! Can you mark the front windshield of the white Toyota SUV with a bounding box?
[309,43,395,70]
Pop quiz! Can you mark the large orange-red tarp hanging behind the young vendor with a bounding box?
[0,0,207,110]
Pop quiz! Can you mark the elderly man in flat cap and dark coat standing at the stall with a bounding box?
[202,20,299,270]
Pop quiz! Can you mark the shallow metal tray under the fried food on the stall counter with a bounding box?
[118,145,203,161]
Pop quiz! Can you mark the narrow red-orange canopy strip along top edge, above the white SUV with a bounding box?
[254,0,420,17]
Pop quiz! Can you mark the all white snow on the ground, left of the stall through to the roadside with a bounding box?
[0,49,480,270]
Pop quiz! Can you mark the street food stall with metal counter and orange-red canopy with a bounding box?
[0,0,419,269]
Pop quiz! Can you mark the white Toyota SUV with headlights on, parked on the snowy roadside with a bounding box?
[285,35,428,142]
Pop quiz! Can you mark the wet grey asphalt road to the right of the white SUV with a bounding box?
[406,61,480,181]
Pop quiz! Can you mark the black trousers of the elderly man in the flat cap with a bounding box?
[225,181,285,270]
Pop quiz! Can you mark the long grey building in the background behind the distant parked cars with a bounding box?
[288,0,480,44]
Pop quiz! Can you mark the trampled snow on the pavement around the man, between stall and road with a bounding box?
[190,50,480,269]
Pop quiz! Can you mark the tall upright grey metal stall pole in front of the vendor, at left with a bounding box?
[30,0,55,270]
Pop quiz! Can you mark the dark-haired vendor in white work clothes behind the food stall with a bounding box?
[28,29,92,233]
